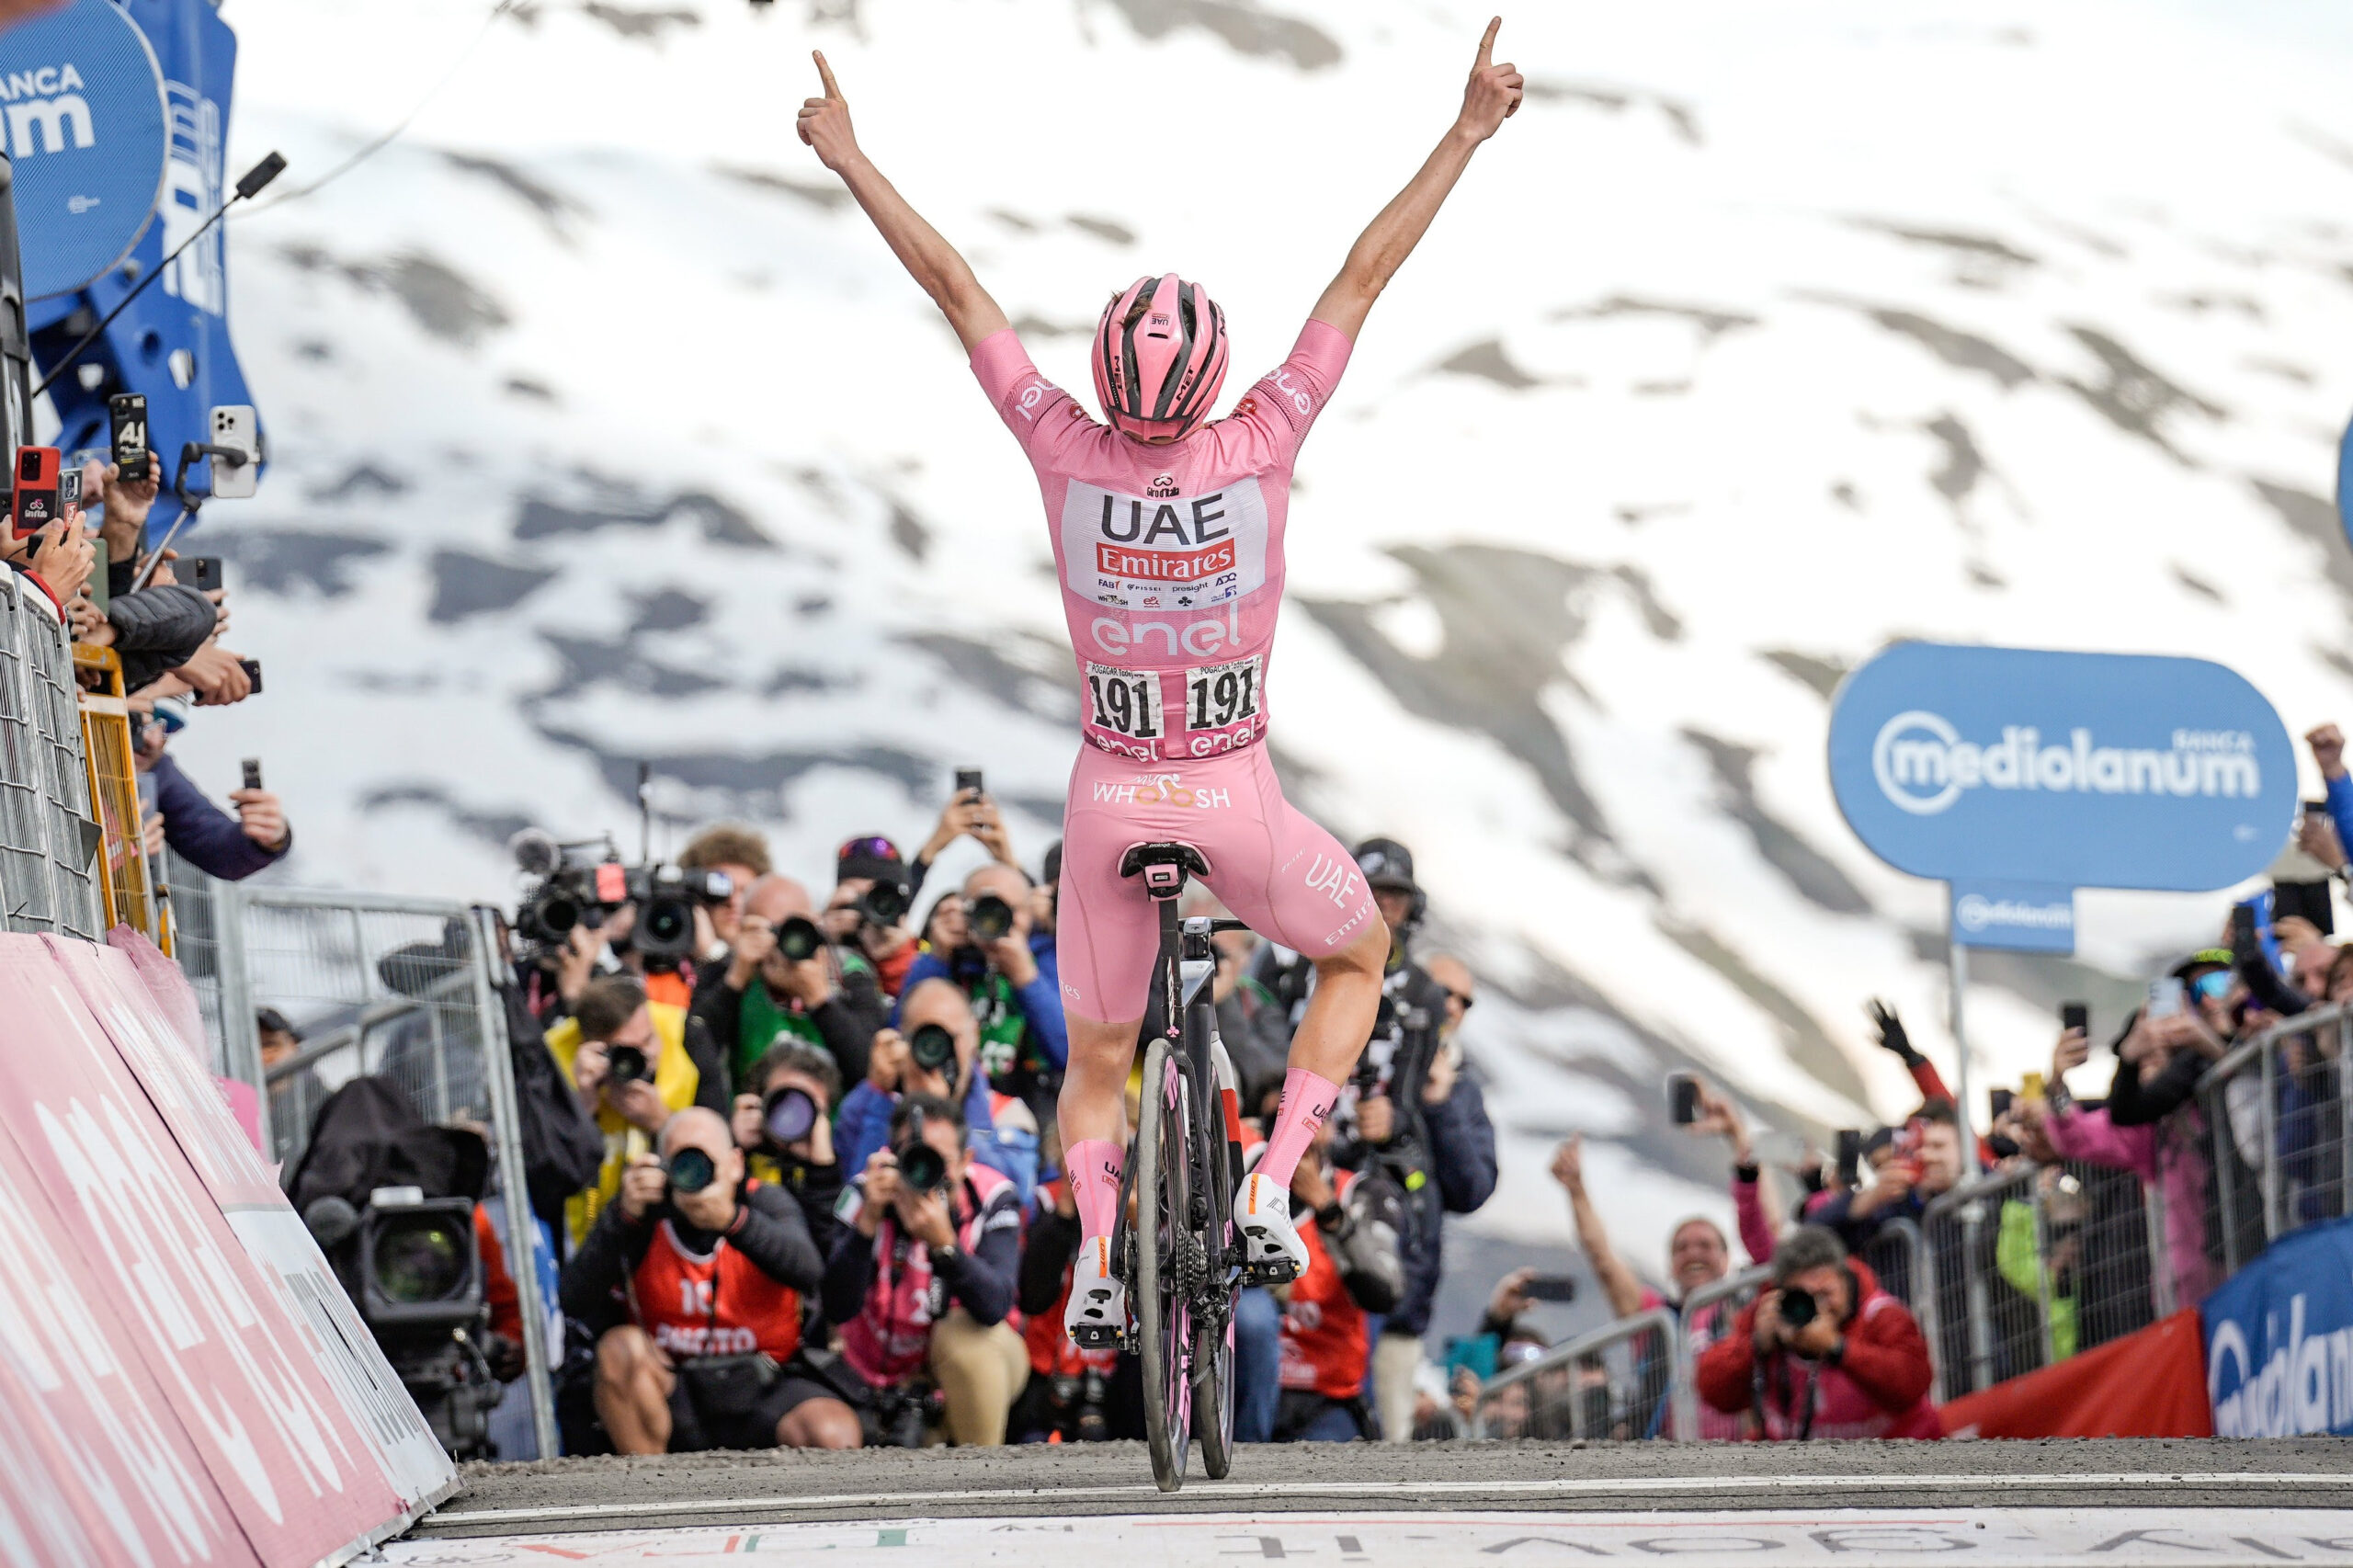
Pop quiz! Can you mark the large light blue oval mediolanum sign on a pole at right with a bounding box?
[1831,642,2297,892]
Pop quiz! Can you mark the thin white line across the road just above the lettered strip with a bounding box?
[421,1471,2353,1533]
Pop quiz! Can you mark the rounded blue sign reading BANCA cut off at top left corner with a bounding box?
[0,0,167,299]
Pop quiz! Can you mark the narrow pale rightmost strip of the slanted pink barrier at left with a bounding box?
[62,930,457,1506]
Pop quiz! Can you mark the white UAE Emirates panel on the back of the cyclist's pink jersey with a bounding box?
[1062,478,1266,617]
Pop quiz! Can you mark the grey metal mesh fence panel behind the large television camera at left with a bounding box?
[169,857,558,1458]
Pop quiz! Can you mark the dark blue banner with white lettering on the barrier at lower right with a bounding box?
[2200,1220,2353,1437]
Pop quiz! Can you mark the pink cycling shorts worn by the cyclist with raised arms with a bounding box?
[1054,746,1381,1024]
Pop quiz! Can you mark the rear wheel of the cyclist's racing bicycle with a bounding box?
[1131,1039,1193,1493]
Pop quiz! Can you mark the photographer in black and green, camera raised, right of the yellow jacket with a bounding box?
[694,873,887,1078]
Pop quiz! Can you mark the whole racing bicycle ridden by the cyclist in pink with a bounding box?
[1091,843,1285,1493]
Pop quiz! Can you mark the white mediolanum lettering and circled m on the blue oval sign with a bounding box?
[1870,709,2264,817]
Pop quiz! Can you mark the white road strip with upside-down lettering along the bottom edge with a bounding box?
[383,1509,2353,1568]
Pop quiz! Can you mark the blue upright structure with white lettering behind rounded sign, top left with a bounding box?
[24,0,255,501]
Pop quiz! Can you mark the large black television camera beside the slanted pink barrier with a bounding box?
[303,1187,506,1460]
